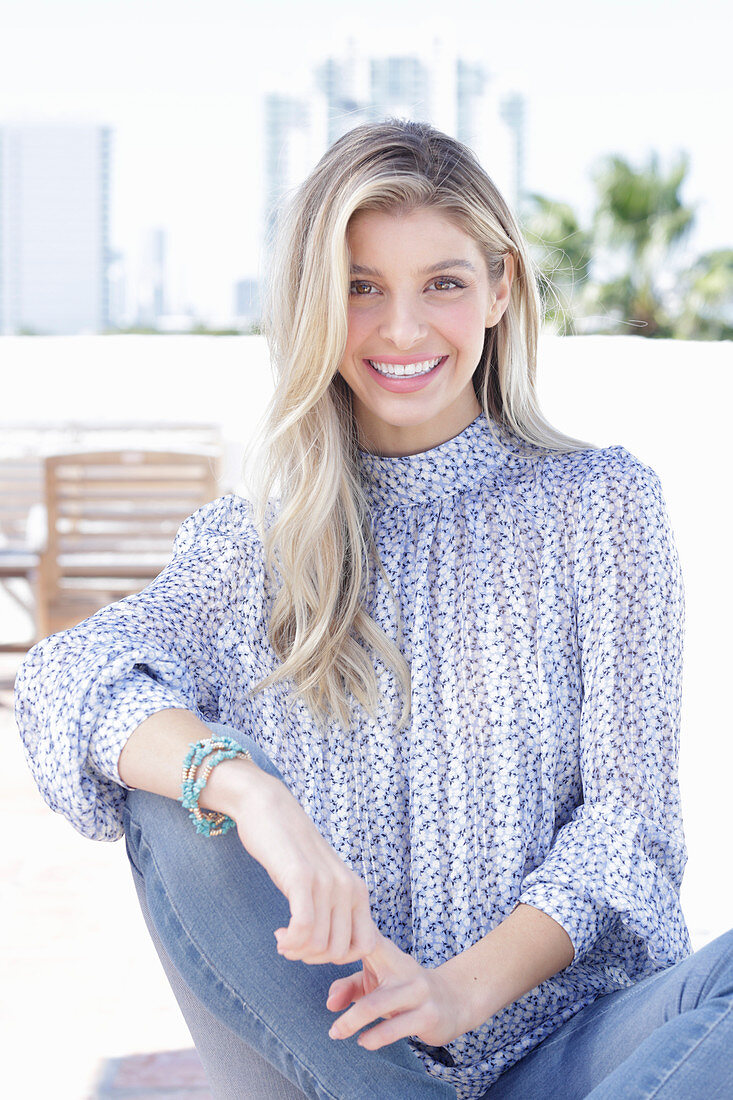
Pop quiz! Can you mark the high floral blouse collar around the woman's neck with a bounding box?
[359,414,538,507]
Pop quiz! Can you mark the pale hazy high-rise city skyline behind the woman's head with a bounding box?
[0,51,526,336]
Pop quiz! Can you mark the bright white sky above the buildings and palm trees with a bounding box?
[0,0,733,312]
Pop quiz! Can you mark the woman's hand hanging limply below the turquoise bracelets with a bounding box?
[221,763,378,964]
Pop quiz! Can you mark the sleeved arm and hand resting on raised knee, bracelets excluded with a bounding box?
[15,497,376,963]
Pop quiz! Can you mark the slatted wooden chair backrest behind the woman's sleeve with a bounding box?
[37,450,219,638]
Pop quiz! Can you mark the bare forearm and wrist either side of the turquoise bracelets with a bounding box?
[118,708,263,816]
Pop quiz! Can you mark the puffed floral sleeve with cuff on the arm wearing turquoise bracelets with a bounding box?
[15,496,260,840]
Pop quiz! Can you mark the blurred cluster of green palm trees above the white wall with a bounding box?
[523,154,733,340]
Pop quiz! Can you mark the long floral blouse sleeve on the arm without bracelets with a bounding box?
[521,448,689,969]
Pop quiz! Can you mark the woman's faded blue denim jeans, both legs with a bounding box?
[124,724,733,1100]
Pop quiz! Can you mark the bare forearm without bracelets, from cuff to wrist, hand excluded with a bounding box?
[438,904,573,1031]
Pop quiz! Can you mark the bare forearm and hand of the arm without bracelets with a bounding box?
[327,905,573,1051]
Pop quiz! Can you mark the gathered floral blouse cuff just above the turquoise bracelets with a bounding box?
[88,669,190,791]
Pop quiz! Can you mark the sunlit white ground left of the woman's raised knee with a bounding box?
[0,655,210,1100]
